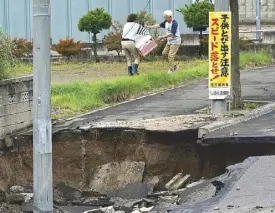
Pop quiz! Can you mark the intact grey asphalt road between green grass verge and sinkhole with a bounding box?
[58,67,275,128]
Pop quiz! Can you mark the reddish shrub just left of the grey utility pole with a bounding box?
[11,38,33,58]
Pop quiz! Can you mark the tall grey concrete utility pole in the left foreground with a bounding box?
[33,0,53,213]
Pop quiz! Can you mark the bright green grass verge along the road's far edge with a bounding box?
[52,52,272,118]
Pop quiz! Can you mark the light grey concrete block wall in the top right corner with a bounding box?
[239,0,275,24]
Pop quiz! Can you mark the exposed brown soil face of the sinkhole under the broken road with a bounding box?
[0,125,275,190]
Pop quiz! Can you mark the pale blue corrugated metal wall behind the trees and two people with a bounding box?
[0,0,192,43]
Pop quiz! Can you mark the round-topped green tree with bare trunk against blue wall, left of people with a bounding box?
[78,8,112,62]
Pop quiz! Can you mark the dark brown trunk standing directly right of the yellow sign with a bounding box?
[230,0,242,108]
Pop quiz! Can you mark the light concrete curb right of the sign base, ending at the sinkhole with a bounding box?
[198,102,275,139]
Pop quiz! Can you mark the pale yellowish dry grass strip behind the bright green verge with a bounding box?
[10,60,204,81]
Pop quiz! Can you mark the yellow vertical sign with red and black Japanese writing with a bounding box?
[208,12,231,100]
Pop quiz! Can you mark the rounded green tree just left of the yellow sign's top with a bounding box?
[177,0,214,55]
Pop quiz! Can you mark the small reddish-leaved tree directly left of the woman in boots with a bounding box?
[104,21,123,61]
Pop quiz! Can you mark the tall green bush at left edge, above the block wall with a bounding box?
[0,28,15,80]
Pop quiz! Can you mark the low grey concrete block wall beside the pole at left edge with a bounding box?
[0,76,33,140]
